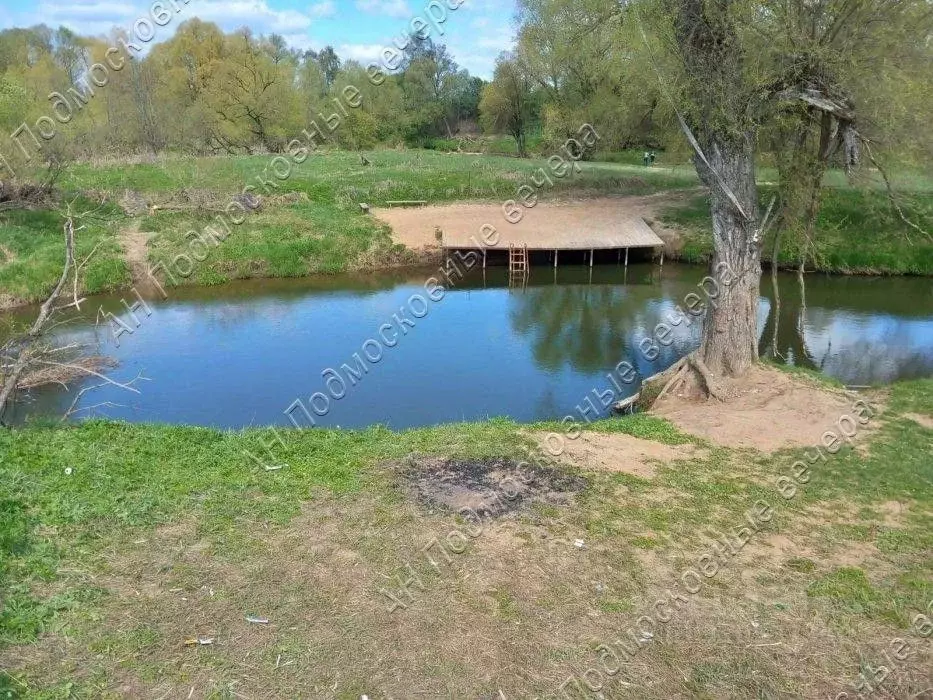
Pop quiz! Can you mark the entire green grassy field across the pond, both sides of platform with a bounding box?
[0,150,933,306]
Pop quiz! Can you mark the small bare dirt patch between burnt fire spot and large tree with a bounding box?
[539,433,705,479]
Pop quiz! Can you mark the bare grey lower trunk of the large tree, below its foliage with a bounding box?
[694,135,761,377]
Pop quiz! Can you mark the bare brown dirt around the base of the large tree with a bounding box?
[651,365,870,452]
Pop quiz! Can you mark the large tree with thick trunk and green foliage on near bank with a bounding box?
[622,0,933,395]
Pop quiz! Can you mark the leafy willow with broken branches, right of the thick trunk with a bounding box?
[750,0,933,267]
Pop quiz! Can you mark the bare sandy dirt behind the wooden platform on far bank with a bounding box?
[373,190,694,253]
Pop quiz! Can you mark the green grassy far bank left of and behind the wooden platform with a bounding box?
[0,151,695,301]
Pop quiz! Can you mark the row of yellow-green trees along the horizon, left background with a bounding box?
[0,19,485,167]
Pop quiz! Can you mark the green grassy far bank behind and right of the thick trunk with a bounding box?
[661,187,933,275]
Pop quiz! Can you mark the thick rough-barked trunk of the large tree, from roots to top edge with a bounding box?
[673,0,761,380]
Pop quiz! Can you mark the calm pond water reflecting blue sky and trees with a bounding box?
[7,265,933,428]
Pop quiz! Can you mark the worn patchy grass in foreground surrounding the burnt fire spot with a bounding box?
[0,380,933,699]
